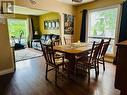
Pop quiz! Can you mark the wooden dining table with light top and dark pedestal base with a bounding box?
[53,42,92,74]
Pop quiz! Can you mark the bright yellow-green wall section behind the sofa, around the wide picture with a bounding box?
[39,12,60,35]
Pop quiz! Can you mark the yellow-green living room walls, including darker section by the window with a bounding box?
[9,12,61,38]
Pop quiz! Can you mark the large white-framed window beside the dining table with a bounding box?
[88,7,119,54]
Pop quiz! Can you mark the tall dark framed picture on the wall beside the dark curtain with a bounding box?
[64,14,74,35]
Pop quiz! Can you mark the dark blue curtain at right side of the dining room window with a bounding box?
[118,1,127,42]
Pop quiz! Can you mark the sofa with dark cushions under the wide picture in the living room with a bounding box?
[31,34,60,50]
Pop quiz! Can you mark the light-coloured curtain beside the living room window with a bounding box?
[28,18,33,47]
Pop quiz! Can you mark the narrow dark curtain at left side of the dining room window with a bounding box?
[80,9,87,42]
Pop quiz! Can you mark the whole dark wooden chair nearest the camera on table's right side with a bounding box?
[77,40,103,83]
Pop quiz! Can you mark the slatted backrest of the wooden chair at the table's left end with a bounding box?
[42,44,55,65]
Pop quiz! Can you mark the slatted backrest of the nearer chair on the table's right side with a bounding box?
[89,40,104,63]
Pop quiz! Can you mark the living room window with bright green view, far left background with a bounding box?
[7,19,28,45]
